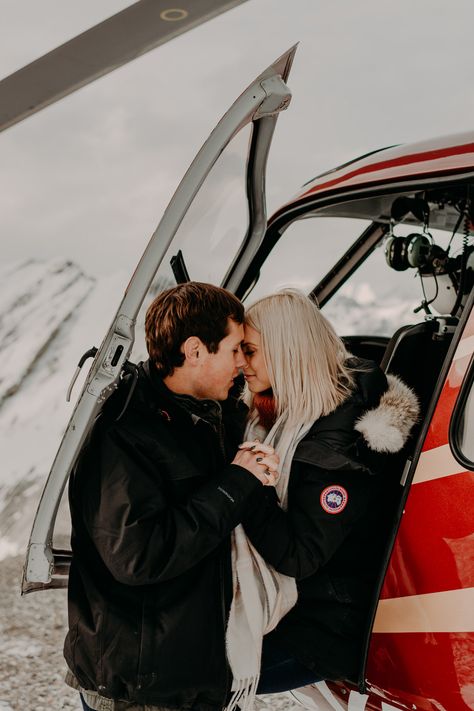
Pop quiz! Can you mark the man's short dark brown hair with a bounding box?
[145,281,244,377]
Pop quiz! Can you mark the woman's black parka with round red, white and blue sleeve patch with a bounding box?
[244,360,417,681]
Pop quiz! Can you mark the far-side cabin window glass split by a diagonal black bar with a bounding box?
[250,215,458,337]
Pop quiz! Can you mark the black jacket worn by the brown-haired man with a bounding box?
[65,363,261,711]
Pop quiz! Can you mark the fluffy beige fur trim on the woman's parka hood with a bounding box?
[355,375,420,453]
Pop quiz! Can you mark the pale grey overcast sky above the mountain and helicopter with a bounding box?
[0,0,474,274]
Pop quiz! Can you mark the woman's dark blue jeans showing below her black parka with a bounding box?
[257,637,321,694]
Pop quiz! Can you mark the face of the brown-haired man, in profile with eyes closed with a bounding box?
[193,319,245,400]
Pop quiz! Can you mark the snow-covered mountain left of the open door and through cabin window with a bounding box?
[0,260,418,558]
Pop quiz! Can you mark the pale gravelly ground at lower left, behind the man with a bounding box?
[0,556,301,711]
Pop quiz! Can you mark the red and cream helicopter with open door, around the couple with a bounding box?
[0,3,474,711]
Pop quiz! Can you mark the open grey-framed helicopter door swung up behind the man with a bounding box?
[22,46,296,593]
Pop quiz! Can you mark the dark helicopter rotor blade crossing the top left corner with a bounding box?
[0,0,250,131]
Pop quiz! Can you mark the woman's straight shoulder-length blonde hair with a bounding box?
[245,289,354,425]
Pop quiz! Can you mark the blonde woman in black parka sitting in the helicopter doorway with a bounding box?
[228,290,418,693]
